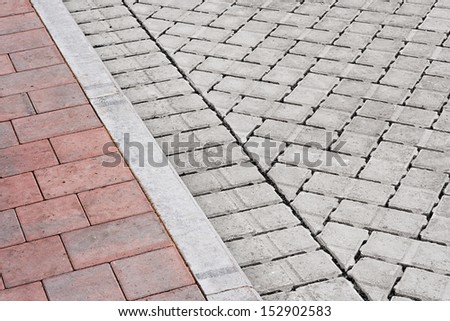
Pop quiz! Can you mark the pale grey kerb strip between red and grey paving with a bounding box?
[32,0,260,300]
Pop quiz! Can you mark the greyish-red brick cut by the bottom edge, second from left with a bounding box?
[44,264,125,301]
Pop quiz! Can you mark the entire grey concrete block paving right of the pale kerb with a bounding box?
[66,0,450,300]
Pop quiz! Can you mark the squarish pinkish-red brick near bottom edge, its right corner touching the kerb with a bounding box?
[112,247,194,300]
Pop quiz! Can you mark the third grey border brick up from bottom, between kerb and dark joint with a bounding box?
[227,226,319,266]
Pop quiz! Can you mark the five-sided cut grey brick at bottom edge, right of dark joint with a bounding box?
[348,258,402,301]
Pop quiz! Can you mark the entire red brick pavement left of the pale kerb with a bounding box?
[0,0,203,300]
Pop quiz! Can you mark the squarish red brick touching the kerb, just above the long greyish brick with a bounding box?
[78,181,152,224]
